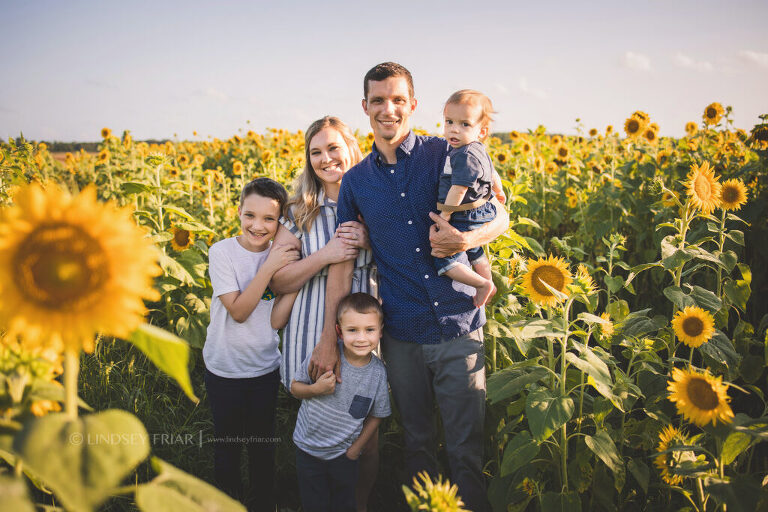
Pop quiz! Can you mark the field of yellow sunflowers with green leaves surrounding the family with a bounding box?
[0,103,768,512]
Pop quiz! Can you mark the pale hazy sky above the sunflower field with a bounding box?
[0,0,768,141]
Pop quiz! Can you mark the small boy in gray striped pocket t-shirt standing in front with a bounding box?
[291,293,390,512]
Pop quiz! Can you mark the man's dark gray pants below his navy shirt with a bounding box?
[381,329,490,512]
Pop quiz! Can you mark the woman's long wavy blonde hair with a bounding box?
[286,116,363,232]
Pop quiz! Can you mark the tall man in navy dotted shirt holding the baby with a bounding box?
[310,62,508,512]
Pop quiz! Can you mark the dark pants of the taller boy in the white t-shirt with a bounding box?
[205,370,280,512]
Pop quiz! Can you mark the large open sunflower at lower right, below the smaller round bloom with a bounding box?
[667,368,733,427]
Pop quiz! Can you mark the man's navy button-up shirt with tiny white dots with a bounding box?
[338,132,485,343]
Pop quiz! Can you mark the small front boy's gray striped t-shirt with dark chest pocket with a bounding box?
[293,343,391,460]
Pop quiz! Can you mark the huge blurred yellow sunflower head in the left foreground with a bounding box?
[0,184,160,351]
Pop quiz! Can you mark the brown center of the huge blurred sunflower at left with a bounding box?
[13,224,108,311]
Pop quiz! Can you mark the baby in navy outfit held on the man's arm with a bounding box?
[435,89,501,307]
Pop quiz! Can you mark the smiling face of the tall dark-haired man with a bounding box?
[363,76,416,142]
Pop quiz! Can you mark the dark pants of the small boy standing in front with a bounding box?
[296,448,357,512]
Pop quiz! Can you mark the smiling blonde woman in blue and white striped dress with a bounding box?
[270,116,378,510]
